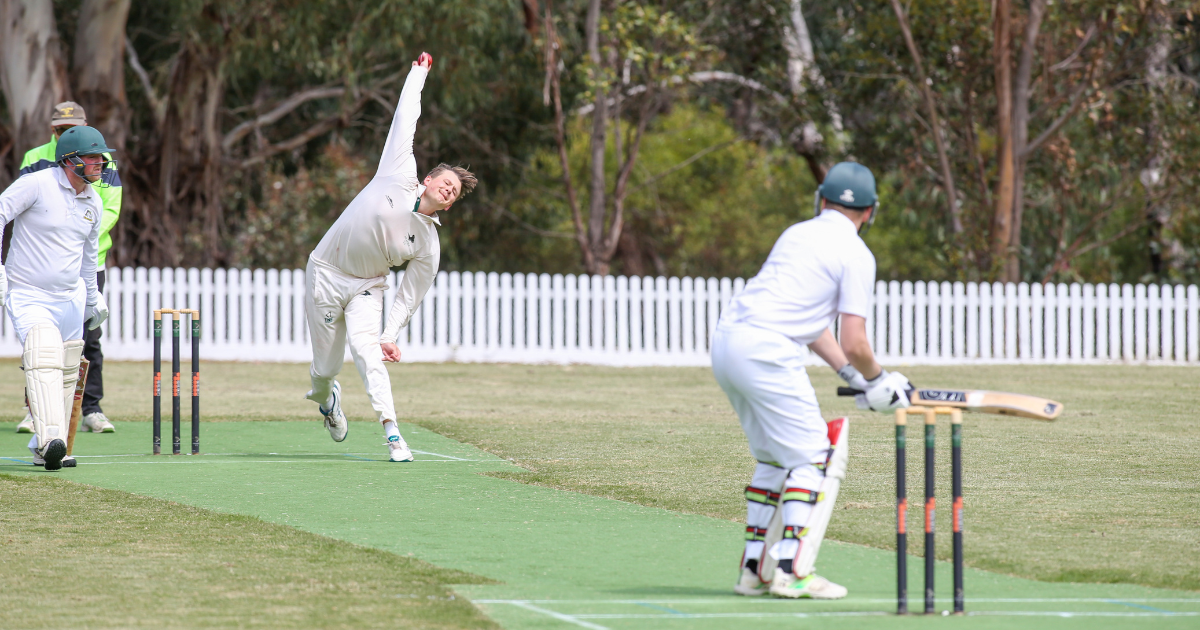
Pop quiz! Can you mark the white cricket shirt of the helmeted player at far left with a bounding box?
[0,167,104,304]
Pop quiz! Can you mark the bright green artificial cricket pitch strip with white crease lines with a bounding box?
[0,421,1200,630]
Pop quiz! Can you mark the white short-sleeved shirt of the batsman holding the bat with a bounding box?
[721,210,875,346]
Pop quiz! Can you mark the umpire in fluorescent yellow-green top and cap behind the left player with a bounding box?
[17,101,121,433]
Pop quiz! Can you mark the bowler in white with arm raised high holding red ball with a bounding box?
[305,53,476,462]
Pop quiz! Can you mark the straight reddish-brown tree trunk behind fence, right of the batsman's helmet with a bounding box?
[991,0,1015,277]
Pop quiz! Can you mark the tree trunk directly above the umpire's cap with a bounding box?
[72,0,130,153]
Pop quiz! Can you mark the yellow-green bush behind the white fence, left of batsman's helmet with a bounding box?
[512,106,816,277]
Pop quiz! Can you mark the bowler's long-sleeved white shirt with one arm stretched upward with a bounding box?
[311,66,442,343]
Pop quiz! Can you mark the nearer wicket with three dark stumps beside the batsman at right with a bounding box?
[896,407,965,614]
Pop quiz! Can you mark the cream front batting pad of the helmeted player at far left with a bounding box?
[22,324,66,449]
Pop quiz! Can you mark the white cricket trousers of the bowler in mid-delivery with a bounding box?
[305,258,396,421]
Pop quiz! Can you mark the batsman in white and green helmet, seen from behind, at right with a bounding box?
[713,162,912,599]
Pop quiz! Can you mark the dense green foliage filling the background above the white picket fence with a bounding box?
[7,0,1200,282]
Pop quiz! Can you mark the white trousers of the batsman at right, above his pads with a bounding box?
[713,324,829,469]
